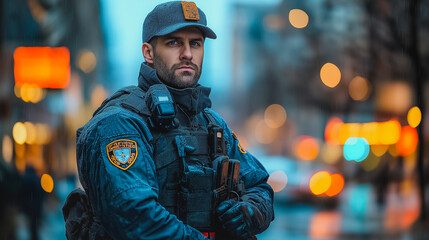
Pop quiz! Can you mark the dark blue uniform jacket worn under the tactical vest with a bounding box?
[76,63,274,239]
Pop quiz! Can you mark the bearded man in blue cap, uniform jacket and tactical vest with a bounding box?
[63,1,274,239]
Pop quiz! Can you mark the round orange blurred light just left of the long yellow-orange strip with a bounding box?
[293,136,319,160]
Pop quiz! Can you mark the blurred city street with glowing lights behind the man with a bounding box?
[0,0,429,240]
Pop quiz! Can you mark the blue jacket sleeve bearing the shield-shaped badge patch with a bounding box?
[77,109,205,239]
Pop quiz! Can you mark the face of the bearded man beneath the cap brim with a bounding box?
[153,27,204,88]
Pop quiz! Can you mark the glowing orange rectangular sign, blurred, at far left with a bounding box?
[13,47,70,88]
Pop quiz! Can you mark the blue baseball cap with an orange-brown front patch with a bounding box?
[143,1,216,42]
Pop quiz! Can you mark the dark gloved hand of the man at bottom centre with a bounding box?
[216,200,263,239]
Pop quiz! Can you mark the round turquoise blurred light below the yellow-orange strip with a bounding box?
[343,137,369,162]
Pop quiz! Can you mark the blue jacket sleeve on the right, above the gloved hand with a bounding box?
[206,110,274,234]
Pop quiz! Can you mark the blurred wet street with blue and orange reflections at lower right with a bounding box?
[258,184,429,240]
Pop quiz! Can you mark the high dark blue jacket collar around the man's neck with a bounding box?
[138,62,211,115]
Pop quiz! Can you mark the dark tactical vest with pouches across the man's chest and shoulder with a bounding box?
[94,86,221,232]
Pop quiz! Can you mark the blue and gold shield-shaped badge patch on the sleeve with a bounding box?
[106,139,137,170]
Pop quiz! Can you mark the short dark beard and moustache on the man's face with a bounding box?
[153,54,202,89]
